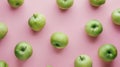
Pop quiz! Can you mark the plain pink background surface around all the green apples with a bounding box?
[0,0,120,67]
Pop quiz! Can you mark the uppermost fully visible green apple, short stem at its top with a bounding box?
[28,13,46,31]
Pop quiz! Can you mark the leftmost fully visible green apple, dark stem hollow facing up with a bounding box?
[14,41,33,60]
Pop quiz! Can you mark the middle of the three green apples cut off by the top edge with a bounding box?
[56,0,74,10]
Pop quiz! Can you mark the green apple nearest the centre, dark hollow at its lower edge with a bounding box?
[50,32,68,49]
